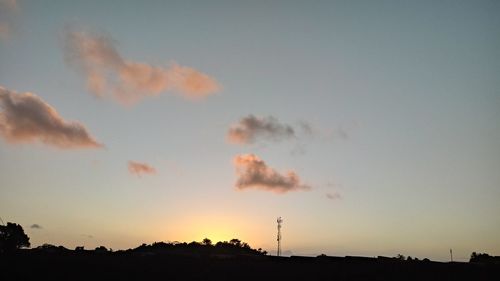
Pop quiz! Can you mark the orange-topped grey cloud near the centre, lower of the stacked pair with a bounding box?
[234,154,311,193]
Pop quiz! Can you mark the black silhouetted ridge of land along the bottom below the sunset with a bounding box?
[0,242,500,280]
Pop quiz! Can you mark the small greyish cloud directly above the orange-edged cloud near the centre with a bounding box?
[227,114,295,144]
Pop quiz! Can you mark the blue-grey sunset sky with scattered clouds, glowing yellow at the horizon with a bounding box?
[0,0,500,261]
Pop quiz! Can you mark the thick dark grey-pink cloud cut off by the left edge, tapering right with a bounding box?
[0,86,103,149]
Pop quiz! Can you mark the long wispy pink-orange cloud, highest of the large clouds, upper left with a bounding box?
[64,27,221,105]
